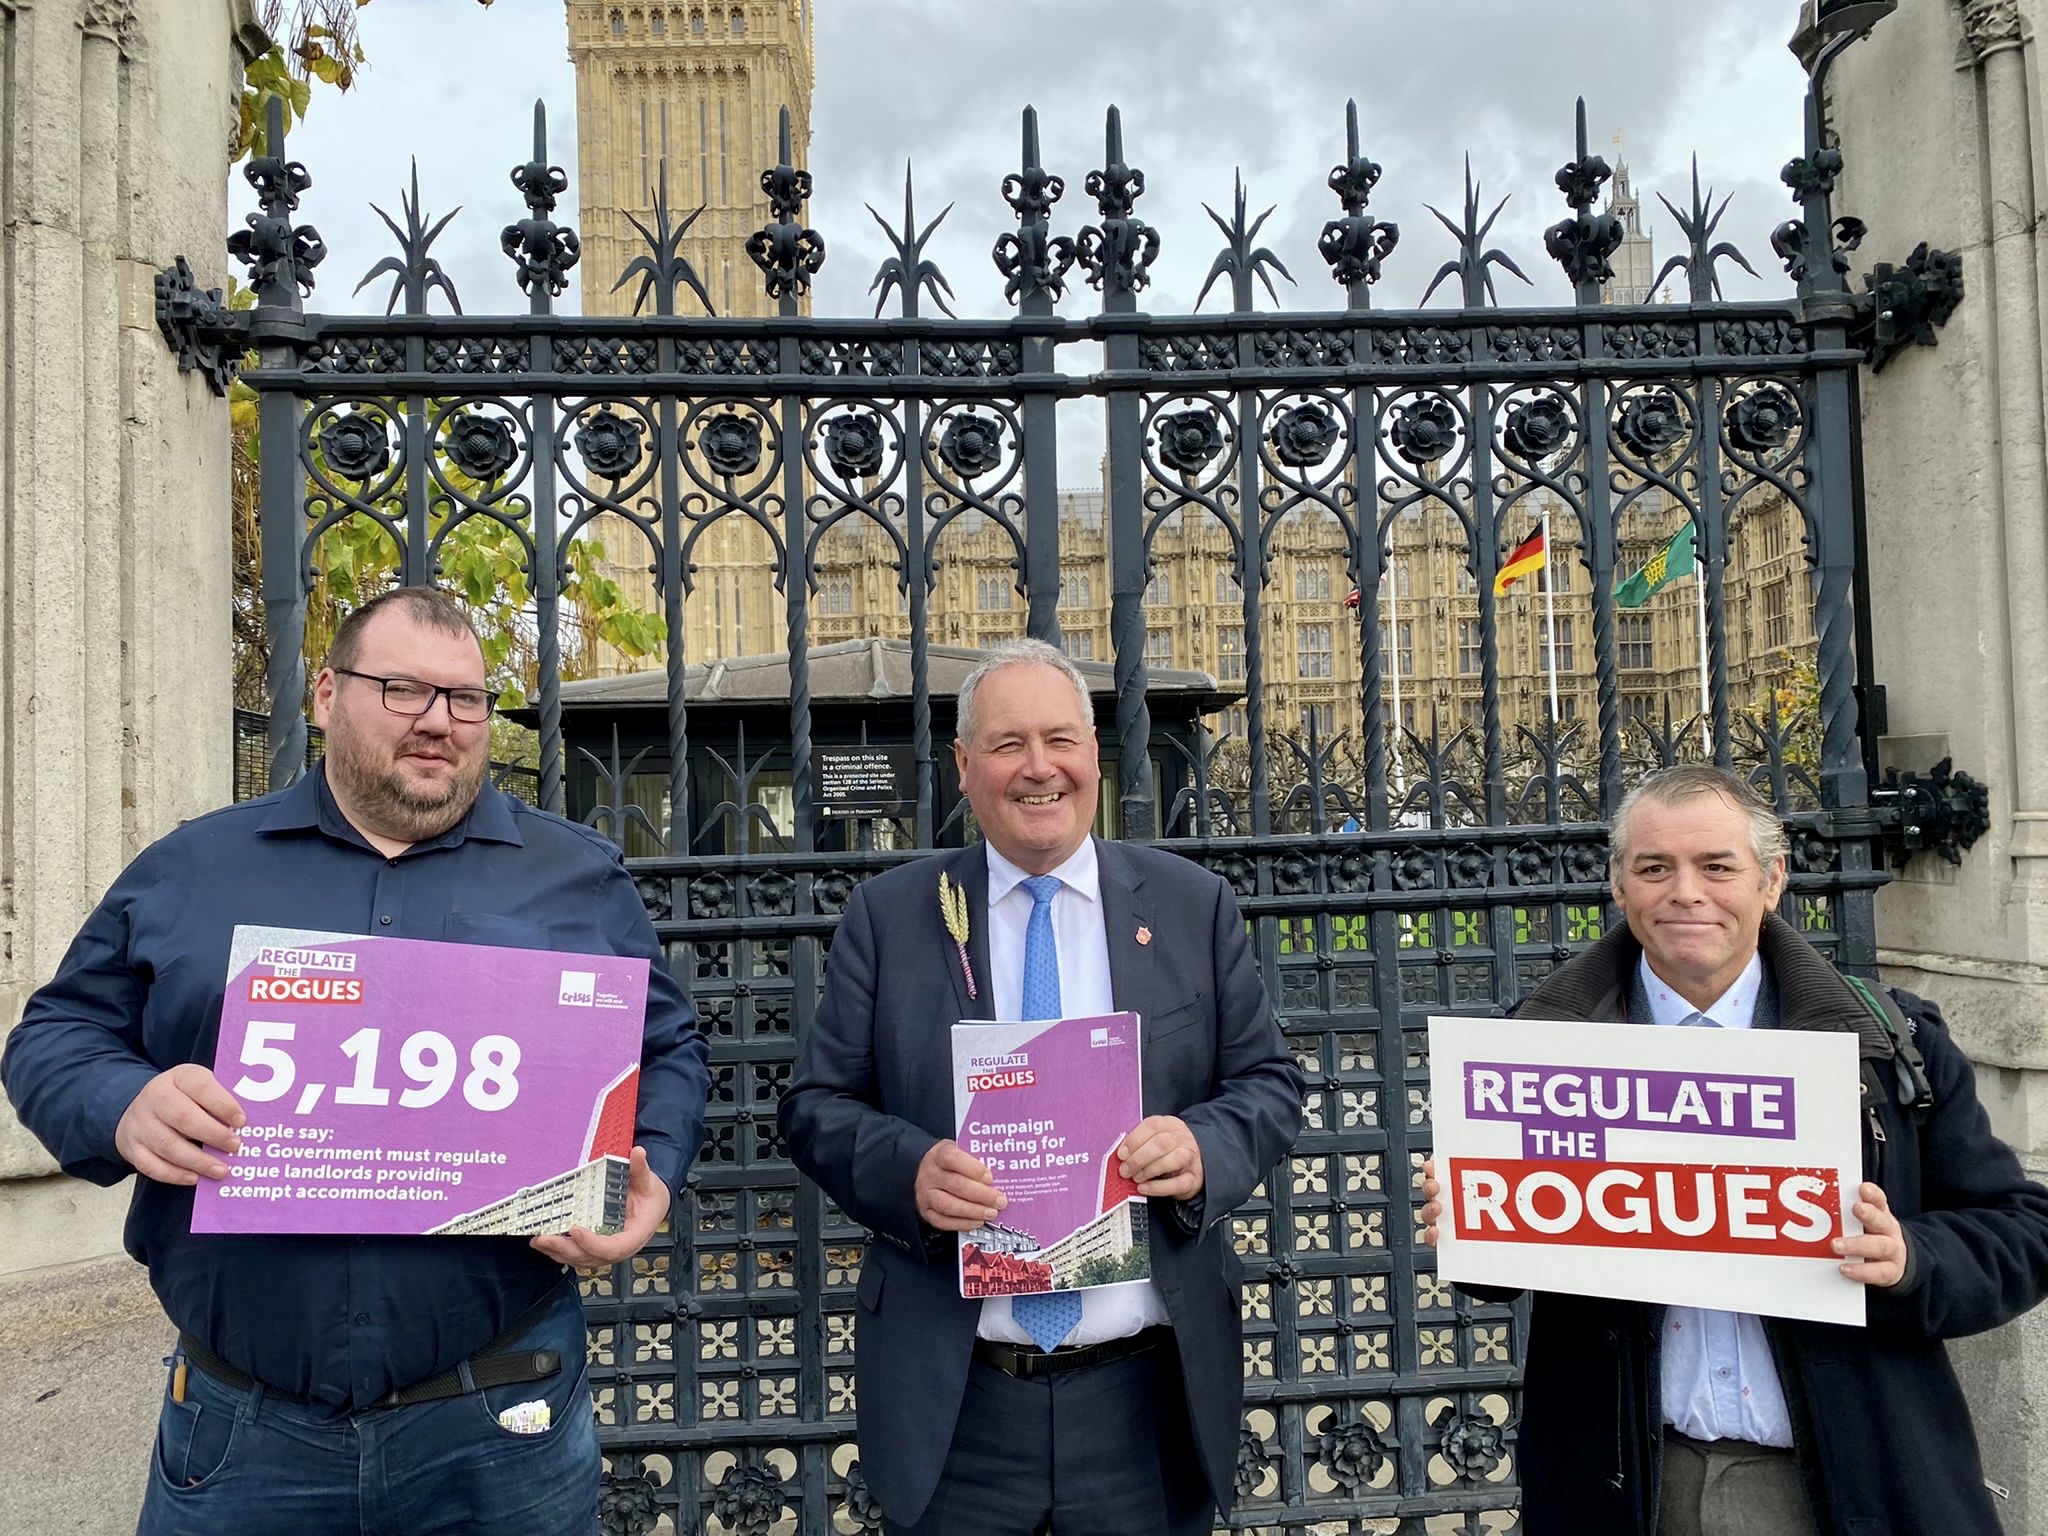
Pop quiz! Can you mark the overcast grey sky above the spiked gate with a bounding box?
[231,0,1804,479]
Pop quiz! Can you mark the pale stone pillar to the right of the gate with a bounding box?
[1829,0,2048,1536]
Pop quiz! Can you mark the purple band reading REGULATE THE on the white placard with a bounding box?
[1464,1061,1798,1157]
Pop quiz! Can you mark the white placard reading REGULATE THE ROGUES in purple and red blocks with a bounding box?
[1430,1016,1864,1327]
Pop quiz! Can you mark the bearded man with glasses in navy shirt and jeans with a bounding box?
[0,588,709,1536]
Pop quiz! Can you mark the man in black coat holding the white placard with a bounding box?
[1421,766,2048,1536]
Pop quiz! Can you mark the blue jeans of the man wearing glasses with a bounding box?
[135,1290,598,1536]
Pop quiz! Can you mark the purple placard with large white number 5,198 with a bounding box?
[193,928,647,1233]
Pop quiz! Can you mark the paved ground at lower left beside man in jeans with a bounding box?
[0,1257,170,1536]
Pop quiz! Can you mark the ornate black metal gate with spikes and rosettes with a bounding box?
[158,66,1954,1532]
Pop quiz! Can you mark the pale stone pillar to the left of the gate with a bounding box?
[0,0,266,1274]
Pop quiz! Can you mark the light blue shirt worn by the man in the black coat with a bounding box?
[1642,954,1792,1448]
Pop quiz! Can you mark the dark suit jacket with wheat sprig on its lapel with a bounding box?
[780,840,1300,1524]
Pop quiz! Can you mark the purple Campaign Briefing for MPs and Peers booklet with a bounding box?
[952,1014,1151,1298]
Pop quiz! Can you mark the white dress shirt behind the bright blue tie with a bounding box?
[975,838,1167,1343]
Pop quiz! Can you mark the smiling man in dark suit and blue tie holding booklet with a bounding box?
[780,641,1300,1536]
